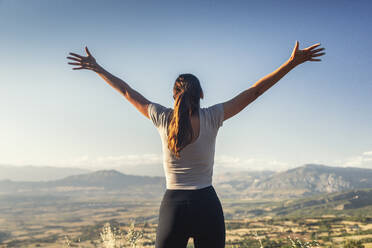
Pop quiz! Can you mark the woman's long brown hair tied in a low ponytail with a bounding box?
[168,73,203,158]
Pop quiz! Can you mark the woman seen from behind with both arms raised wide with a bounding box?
[67,41,325,248]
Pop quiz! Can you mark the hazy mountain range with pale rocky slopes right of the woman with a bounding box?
[218,164,372,198]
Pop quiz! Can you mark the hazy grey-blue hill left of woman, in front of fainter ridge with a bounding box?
[0,170,165,197]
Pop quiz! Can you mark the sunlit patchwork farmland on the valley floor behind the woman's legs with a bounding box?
[0,194,372,247]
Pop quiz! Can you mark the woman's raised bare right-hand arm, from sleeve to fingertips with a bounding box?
[223,41,325,120]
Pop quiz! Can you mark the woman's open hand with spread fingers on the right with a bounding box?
[290,41,325,65]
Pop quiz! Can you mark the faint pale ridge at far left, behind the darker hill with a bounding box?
[0,165,91,182]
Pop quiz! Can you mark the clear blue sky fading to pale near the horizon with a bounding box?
[0,0,372,173]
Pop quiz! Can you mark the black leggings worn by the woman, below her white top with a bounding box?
[155,186,226,248]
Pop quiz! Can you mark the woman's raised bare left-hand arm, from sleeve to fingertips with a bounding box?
[67,47,151,118]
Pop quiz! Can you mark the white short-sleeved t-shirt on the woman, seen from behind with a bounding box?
[148,103,224,189]
